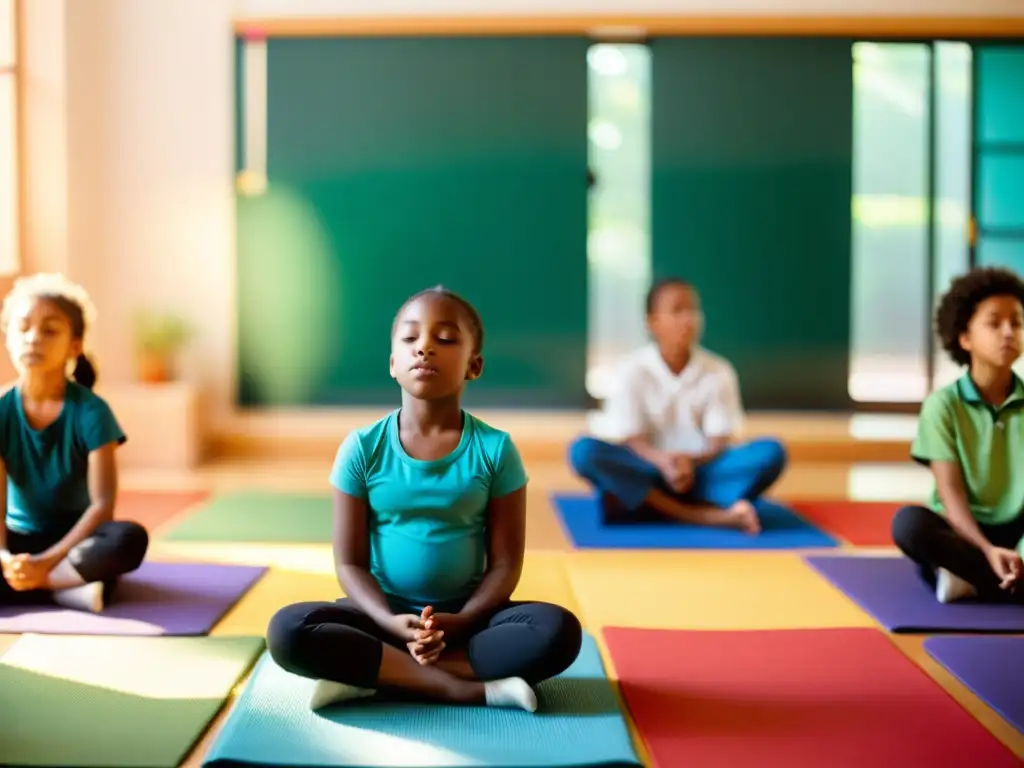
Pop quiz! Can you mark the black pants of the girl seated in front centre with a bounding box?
[266,598,583,689]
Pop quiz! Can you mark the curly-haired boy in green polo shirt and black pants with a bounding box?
[892,267,1024,603]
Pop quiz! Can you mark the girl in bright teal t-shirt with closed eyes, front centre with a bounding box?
[267,288,582,712]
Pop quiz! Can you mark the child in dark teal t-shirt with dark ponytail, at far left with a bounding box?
[0,274,148,612]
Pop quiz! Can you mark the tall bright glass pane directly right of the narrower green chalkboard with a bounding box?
[850,43,930,402]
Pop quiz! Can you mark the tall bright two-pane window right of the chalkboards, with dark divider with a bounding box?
[850,42,974,403]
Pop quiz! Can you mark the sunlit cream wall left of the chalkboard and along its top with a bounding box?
[23,0,1024,429]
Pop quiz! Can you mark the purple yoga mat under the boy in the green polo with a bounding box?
[805,556,1024,634]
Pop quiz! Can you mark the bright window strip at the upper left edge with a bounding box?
[0,0,20,274]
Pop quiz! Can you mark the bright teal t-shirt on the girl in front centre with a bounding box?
[331,411,526,612]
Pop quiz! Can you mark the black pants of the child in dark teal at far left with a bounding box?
[0,520,150,604]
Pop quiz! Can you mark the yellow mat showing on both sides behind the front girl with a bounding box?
[210,552,580,636]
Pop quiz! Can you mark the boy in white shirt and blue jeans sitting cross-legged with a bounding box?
[569,278,785,534]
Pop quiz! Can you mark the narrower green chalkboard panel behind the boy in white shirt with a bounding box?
[651,39,853,409]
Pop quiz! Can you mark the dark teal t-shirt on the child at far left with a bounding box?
[0,381,127,539]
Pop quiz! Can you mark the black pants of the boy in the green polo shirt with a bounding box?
[893,507,1024,602]
